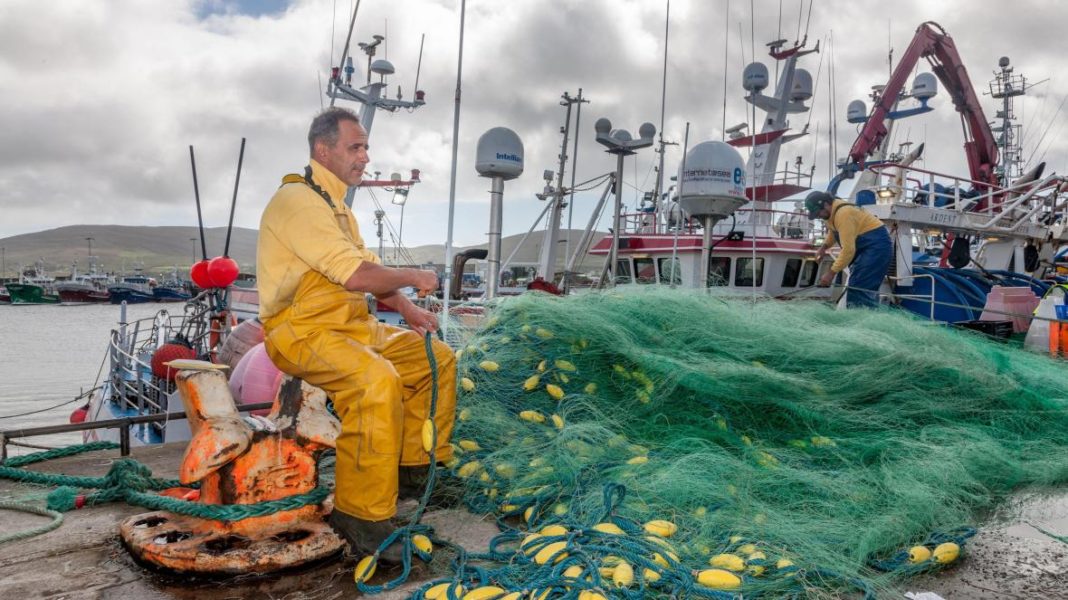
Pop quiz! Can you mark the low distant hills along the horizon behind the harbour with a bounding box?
[0,225,603,278]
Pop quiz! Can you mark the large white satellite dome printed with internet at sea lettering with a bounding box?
[678,141,748,218]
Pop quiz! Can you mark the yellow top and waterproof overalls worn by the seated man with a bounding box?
[256,160,456,521]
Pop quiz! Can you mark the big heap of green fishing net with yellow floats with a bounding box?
[419,290,1068,598]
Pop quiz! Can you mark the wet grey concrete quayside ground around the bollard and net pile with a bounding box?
[0,444,1068,600]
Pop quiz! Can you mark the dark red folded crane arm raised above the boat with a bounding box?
[849,21,998,185]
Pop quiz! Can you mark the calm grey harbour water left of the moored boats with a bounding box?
[0,303,162,454]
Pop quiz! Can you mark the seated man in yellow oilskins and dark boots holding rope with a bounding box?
[256,108,456,562]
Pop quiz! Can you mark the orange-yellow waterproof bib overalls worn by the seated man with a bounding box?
[264,170,456,521]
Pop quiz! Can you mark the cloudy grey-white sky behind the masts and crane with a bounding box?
[0,0,1068,246]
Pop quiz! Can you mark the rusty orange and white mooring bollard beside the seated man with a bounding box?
[120,368,344,574]
